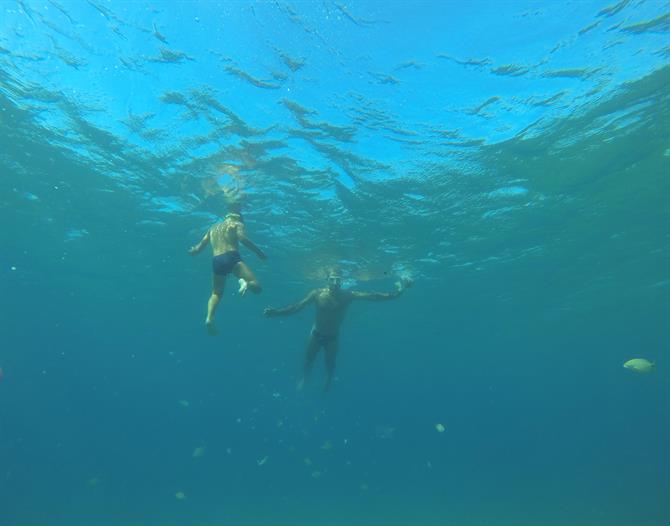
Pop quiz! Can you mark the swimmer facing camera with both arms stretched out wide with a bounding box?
[263,271,412,391]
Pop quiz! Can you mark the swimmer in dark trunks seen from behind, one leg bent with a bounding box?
[188,212,267,334]
